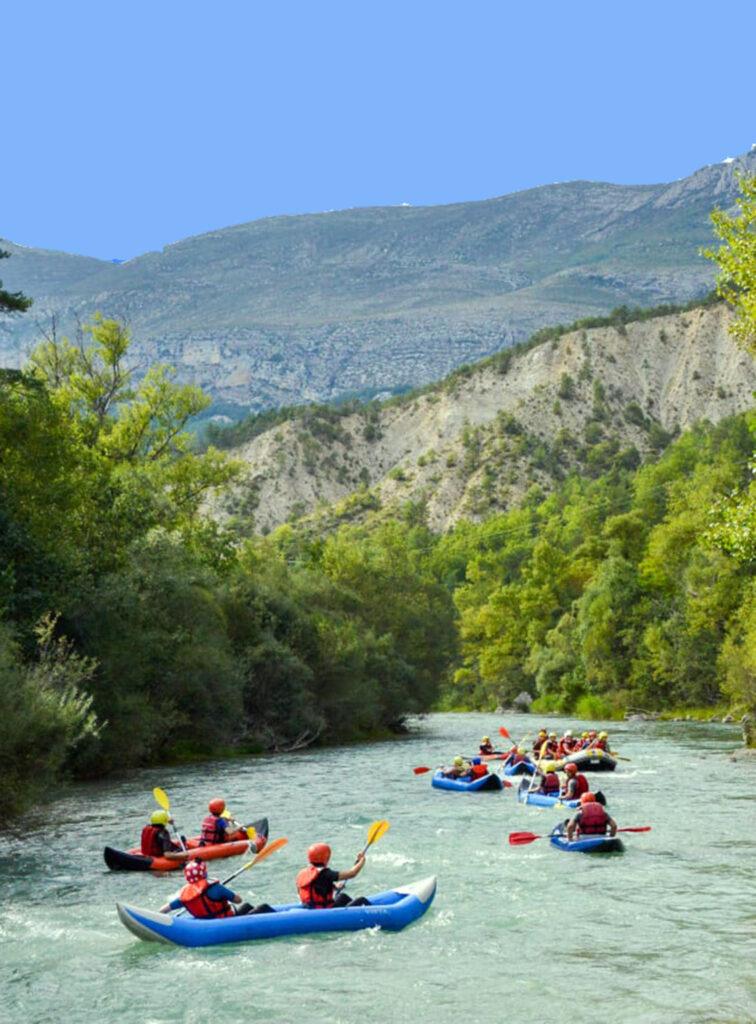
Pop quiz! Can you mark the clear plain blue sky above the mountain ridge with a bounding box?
[5,0,756,258]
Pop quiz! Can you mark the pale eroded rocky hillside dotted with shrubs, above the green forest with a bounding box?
[222,303,756,532]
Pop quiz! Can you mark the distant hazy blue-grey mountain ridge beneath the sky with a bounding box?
[0,148,756,408]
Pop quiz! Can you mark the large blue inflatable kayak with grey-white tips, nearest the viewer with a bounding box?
[116,878,435,946]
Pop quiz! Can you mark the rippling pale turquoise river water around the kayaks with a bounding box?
[0,715,756,1024]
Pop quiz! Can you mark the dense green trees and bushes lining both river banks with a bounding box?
[0,182,756,814]
